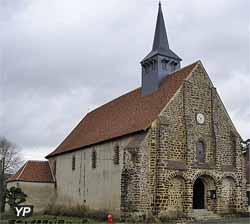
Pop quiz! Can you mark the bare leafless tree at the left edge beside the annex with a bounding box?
[0,136,22,212]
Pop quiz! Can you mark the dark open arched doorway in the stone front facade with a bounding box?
[193,178,205,209]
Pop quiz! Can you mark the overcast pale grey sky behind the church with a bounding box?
[0,0,250,159]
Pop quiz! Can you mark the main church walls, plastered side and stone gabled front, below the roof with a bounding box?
[45,64,246,220]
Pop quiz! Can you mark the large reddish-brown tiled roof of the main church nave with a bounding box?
[46,62,198,158]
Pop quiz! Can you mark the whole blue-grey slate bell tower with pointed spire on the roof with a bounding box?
[141,3,181,96]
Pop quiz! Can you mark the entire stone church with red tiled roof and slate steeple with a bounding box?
[9,4,247,219]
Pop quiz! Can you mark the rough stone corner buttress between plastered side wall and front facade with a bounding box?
[121,132,153,221]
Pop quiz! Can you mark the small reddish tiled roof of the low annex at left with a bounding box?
[7,160,54,183]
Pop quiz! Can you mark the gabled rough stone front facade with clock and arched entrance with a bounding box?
[131,64,246,219]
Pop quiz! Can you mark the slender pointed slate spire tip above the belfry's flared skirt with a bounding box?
[152,2,169,51]
